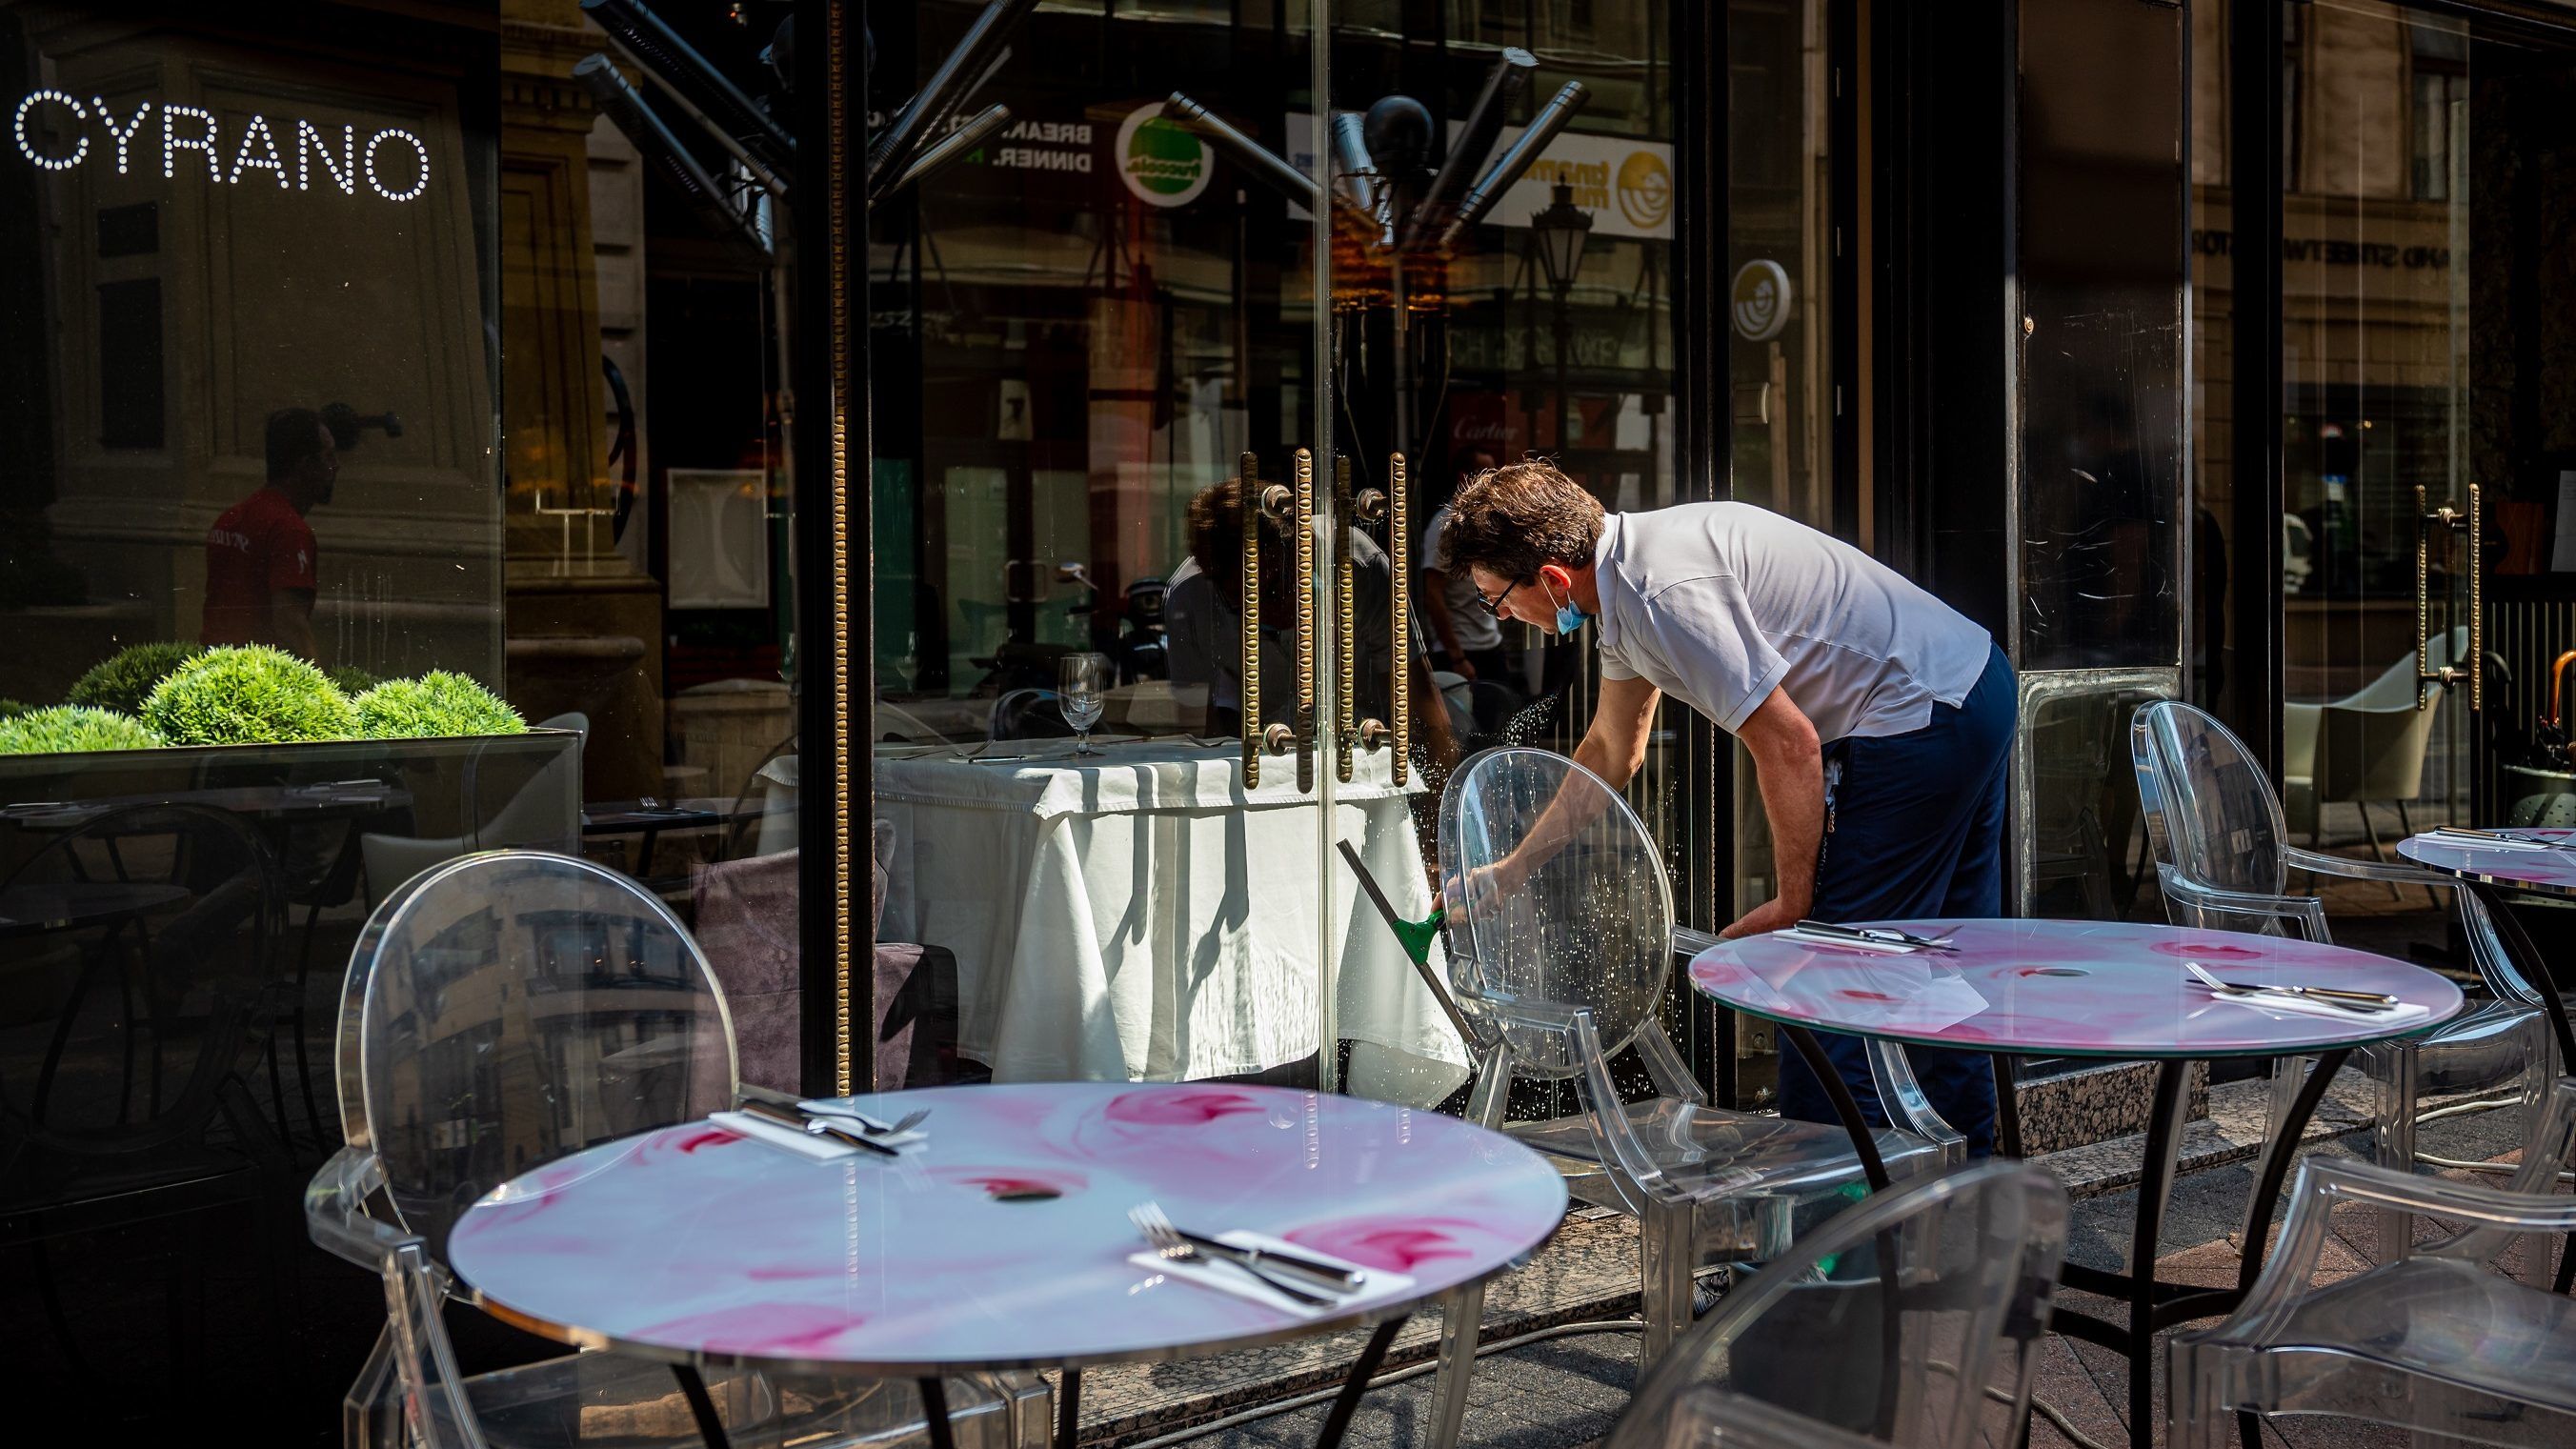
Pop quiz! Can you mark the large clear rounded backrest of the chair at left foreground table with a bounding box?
[337,851,736,1258]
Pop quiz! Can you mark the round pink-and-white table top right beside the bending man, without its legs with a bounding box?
[1690,920,2463,1057]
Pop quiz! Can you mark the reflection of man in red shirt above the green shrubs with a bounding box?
[198,408,340,660]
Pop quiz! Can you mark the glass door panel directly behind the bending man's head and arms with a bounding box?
[1293,0,1708,1111]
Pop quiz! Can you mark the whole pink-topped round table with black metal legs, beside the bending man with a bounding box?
[1690,920,2465,1449]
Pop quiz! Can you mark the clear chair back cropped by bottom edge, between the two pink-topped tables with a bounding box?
[1607,1163,2068,1449]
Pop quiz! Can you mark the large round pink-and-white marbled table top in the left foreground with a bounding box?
[448,1083,1566,1377]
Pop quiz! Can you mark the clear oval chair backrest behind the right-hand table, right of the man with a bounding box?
[2130,698,2290,895]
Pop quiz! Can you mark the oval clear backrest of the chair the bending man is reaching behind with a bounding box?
[1440,748,1672,1077]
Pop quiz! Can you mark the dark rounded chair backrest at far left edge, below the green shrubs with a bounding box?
[0,804,286,1159]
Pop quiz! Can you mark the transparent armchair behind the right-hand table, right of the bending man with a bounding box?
[2130,698,2555,1245]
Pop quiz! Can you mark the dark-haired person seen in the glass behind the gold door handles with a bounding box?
[1164,479,1458,766]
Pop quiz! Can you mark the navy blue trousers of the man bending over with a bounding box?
[1780,647,2020,1157]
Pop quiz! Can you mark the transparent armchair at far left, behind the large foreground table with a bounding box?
[304,851,1049,1449]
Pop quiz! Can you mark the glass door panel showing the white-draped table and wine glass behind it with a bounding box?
[853,0,1370,1088]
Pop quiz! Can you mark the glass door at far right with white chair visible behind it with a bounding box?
[2280,0,2509,956]
